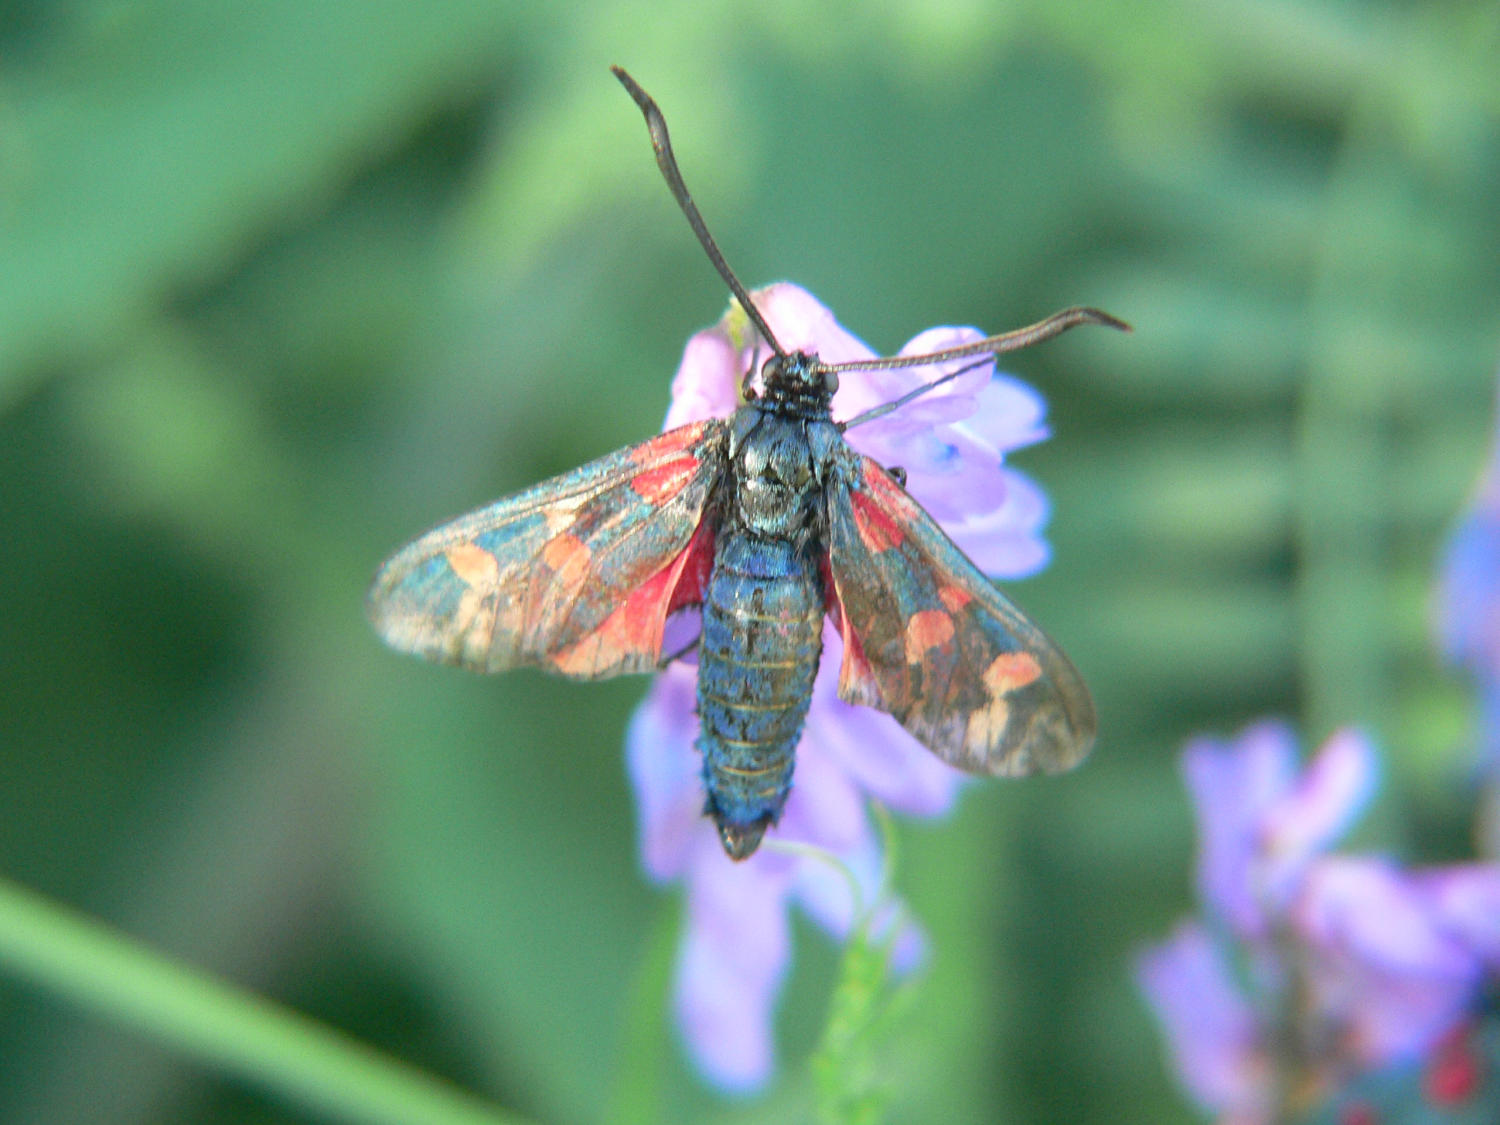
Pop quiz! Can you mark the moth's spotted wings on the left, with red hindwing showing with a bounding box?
[366,419,729,680]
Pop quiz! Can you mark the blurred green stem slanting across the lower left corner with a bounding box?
[0,879,524,1125]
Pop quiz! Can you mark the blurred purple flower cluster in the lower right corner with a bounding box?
[1139,723,1500,1125]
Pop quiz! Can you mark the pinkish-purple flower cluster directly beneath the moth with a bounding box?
[627,284,1047,1091]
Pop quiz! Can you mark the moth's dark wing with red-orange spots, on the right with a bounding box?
[828,447,1095,776]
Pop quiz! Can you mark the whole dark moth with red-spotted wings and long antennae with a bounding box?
[368,68,1128,860]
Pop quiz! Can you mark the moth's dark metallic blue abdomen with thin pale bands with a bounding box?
[698,531,824,860]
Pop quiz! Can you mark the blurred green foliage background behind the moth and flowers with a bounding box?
[0,0,1500,1125]
